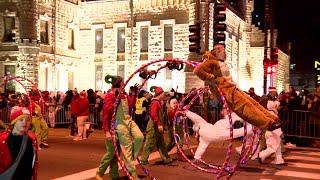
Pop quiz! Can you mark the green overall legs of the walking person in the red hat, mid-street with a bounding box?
[141,120,170,163]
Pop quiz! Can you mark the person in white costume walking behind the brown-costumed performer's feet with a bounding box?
[259,100,284,164]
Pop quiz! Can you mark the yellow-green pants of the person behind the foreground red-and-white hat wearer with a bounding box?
[32,116,49,145]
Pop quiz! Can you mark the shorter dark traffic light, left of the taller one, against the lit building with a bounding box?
[189,23,201,53]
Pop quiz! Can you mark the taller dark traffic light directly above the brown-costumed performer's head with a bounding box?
[213,3,227,44]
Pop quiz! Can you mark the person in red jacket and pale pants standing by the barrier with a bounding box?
[71,92,89,141]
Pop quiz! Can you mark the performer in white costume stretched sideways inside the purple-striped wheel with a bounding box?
[185,110,252,160]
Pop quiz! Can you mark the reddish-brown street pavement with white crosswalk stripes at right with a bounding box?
[38,129,320,180]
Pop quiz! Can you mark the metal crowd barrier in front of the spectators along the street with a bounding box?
[0,104,320,139]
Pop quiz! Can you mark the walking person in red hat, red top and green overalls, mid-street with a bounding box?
[141,87,172,165]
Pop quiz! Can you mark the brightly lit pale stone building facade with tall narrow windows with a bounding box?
[0,0,289,95]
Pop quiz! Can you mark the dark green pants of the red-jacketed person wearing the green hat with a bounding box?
[97,140,119,179]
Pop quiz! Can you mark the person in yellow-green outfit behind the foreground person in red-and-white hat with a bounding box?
[30,102,49,150]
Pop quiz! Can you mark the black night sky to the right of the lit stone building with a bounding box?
[254,0,320,71]
